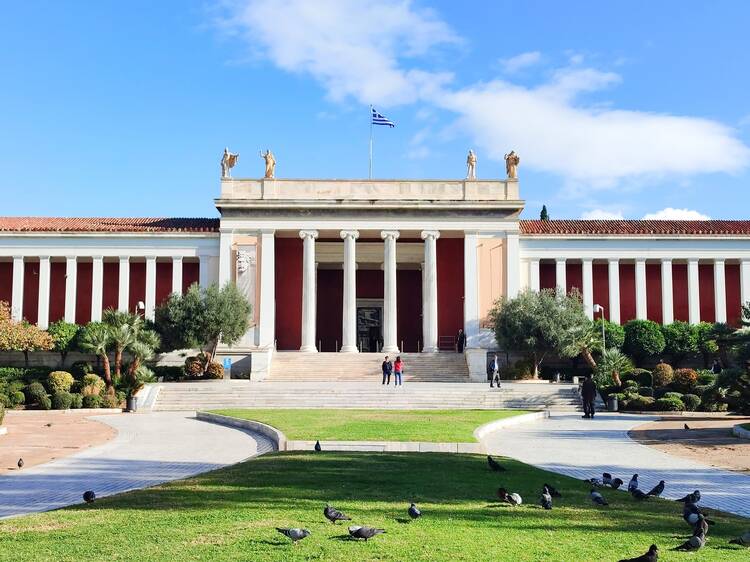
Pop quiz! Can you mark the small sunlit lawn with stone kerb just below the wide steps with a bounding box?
[207,409,528,443]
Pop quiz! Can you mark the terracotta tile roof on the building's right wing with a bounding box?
[520,219,750,236]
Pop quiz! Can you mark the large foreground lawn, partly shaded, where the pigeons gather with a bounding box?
[0,452,748,562]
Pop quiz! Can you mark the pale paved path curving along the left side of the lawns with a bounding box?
[0,412,273,518]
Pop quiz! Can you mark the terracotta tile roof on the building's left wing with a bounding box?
[0,217,219,232]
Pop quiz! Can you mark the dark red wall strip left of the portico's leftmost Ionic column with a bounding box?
[275,238,302,350]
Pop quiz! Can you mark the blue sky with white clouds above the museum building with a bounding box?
[0,0,750,219]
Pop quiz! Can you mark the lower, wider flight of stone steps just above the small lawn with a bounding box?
[153,380,579,411]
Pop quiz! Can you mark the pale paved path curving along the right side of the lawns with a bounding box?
[482,413,750,517]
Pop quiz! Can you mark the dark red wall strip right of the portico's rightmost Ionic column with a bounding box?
[437,238,464,342]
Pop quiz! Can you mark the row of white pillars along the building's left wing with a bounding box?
[11,256,208,329]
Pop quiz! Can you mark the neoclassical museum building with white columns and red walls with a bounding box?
[0,174,750,379]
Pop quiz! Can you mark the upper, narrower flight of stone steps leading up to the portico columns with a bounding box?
[268,351,469,382]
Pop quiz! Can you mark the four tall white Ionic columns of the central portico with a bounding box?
[298,230,440,353]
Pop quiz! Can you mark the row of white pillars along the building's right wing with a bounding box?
[529,258,750,324]
